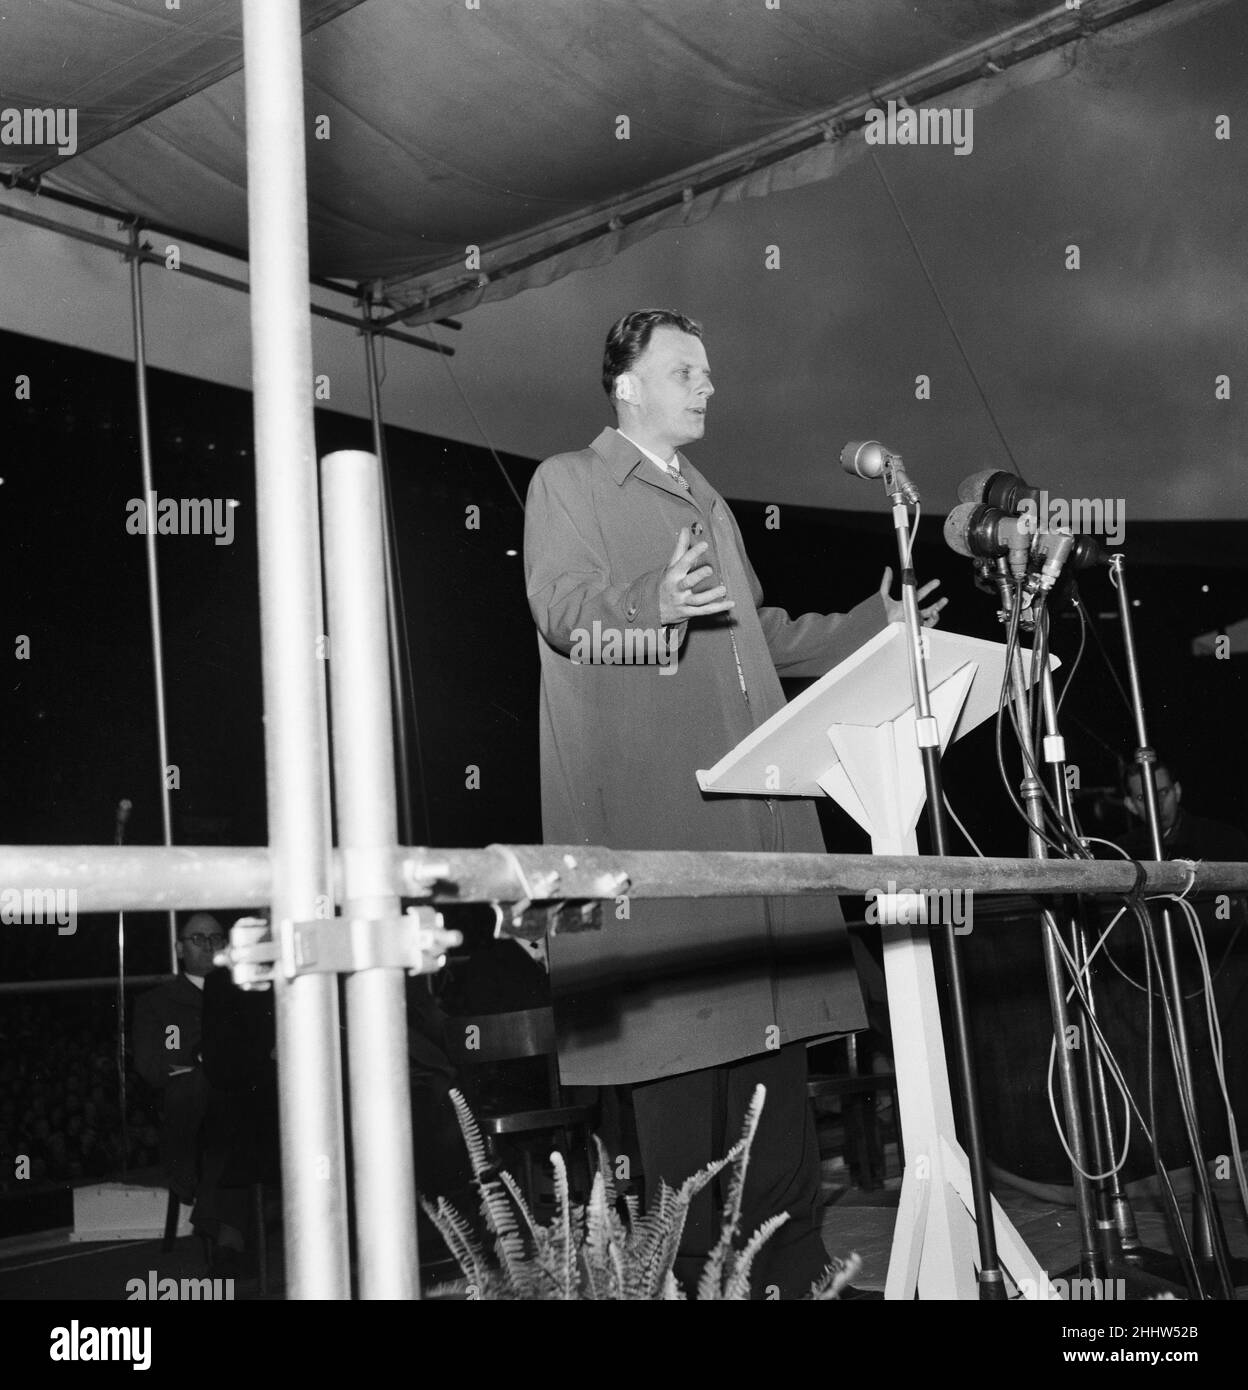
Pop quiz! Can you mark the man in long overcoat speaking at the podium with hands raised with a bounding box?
[524,310,944,1297]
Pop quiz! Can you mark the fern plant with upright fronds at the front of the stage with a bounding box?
[421,1086,860,1301]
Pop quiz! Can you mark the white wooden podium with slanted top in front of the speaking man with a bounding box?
[698,623,1056,1298]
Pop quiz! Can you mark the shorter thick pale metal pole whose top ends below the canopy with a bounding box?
[321,450,420,1300]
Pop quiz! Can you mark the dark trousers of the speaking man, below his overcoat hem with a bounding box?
[632,1043,828,1298]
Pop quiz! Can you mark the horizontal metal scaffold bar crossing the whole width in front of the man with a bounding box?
[0,845,1248,919]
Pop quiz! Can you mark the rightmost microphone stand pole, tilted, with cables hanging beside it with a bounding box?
[1109,552,1235,1298]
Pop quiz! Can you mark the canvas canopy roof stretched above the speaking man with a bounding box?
[0,0,1226,322]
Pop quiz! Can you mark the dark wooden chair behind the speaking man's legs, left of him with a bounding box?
[446,1008,598,1207]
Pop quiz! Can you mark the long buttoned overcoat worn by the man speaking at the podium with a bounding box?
[524,430,887,1086]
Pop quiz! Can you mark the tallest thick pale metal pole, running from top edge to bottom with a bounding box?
[243,0,350,1300]
